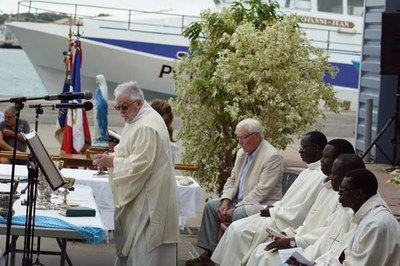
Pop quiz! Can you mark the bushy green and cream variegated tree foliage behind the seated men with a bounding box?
[172,0,339,192]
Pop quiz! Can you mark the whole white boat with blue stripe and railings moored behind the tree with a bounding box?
[7,0,364,110]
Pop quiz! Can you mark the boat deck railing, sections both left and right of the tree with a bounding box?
[14,0,362,55]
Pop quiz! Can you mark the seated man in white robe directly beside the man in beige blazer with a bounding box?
[211,131,327,266]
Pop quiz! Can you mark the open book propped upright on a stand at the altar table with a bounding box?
[21,130,65,190]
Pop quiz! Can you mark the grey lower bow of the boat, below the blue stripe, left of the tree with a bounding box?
[8,22,180,99]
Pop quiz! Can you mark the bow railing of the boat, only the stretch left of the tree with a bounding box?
[13,1,199,34]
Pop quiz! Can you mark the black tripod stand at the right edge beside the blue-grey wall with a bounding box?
[361,75,400,171]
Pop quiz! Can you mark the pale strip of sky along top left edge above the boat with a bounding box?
[0,0,219,13]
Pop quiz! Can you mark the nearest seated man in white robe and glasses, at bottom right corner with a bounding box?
[316,169,400,266]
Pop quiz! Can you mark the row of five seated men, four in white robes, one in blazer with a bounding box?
[186,127,400,266]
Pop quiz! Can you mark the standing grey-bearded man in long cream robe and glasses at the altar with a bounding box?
[94,82,179,266]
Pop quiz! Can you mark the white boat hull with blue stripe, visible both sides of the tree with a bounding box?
[7,1,362,110]
